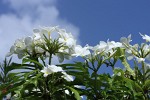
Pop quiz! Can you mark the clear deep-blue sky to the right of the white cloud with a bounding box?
[58,0,150,45]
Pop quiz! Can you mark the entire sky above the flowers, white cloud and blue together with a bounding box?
[0,0,150,59]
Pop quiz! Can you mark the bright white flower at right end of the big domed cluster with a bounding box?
[72,45,90,57]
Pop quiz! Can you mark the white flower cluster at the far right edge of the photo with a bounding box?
[121,33,150,70]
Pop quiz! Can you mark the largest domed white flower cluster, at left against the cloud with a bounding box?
[7,26,94,62]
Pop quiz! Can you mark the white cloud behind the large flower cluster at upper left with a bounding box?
[0,0,79,60]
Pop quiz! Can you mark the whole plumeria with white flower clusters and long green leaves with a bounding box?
[0,26,150,100]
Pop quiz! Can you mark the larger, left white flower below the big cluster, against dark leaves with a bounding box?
[41,65,63,77]
